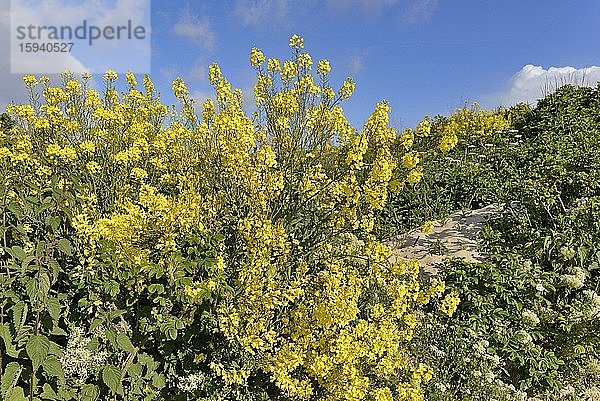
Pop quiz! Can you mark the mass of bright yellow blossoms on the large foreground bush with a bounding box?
[0,35,455,401]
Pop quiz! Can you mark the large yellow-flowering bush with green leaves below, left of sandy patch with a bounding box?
[0,36,454,401]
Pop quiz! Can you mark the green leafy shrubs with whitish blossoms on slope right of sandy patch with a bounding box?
[408,86,600,400]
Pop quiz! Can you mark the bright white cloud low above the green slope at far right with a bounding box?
[488,64,600,106]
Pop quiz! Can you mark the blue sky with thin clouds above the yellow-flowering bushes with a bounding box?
[0,0,600,127]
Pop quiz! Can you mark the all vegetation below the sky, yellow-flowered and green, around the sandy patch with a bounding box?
[0,32,600,401]
